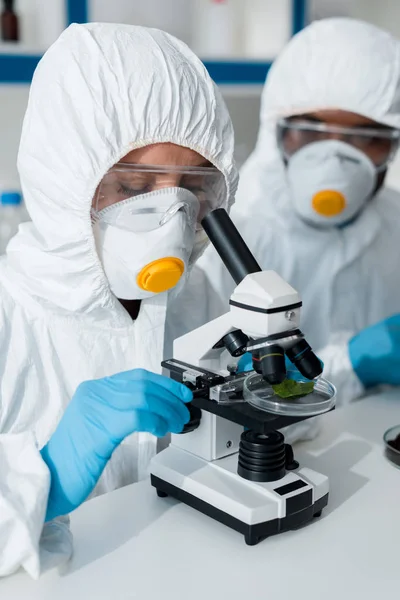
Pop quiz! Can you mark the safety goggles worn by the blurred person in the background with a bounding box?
[277,118,400,170]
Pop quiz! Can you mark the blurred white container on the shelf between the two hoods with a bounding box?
[193,0,238,58]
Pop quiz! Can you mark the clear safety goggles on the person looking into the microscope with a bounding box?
[92,163,227,227]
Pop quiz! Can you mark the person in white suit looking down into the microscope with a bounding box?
[0,24,237,577]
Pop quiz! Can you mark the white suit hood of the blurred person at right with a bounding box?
[234,18,400,224]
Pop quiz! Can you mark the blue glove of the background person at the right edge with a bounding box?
[349,315,400,388]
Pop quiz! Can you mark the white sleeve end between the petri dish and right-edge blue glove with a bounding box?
[316,332,365,406]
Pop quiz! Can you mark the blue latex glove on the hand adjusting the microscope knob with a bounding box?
[41,369,192,521]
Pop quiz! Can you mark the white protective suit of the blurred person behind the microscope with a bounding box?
[201,19,400,404]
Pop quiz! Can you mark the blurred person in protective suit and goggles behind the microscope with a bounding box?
[200,18,400,404]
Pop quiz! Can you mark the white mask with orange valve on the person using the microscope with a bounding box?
[94,188,200,300]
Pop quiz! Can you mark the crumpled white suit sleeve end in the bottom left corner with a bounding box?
[0,433,72,579]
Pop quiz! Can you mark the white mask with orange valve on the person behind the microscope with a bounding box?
[287,140,377,227]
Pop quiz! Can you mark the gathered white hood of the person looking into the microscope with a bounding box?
[8,23,236,321]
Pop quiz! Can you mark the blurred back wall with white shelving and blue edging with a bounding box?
[0,0,400,191]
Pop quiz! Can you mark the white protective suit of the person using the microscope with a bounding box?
[0,24,237,577]
